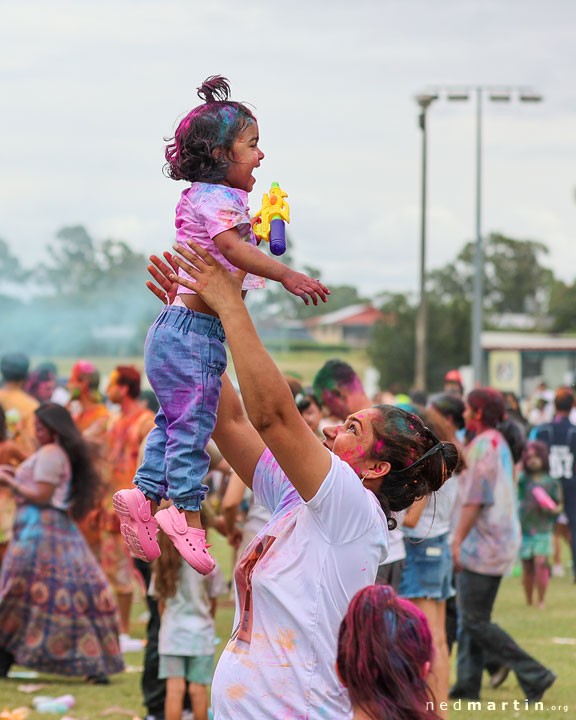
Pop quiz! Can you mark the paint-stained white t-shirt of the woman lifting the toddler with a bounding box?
[212,450,388,720]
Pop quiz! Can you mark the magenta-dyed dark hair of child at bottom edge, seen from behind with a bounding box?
[336,585,439,720]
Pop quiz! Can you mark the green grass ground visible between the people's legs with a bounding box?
[0,536,576,720]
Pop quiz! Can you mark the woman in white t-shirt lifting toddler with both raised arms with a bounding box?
[149,243,459,720]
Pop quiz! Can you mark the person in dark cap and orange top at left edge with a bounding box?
[0,353,40,454]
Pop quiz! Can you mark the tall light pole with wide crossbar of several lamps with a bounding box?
[414,85,542,386]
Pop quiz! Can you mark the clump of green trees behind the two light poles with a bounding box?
[369,234,552,388]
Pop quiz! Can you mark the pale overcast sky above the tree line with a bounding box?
[0,0,576,294]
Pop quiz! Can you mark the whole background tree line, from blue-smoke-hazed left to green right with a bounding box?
[0,225,576,394]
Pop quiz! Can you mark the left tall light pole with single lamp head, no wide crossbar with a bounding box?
[414,93,438,390]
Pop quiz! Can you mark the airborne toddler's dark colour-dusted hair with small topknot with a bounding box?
[164,75,256,183]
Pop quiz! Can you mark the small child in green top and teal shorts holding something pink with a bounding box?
[518,440,561,609]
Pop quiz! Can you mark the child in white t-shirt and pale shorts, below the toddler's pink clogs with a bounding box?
[149,533,227,720]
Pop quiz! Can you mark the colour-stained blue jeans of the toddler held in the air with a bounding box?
[134,305,226,510]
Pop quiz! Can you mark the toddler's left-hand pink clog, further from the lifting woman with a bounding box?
[112,487,160,562]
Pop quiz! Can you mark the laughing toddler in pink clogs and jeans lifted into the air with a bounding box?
[114,76,328,573]
